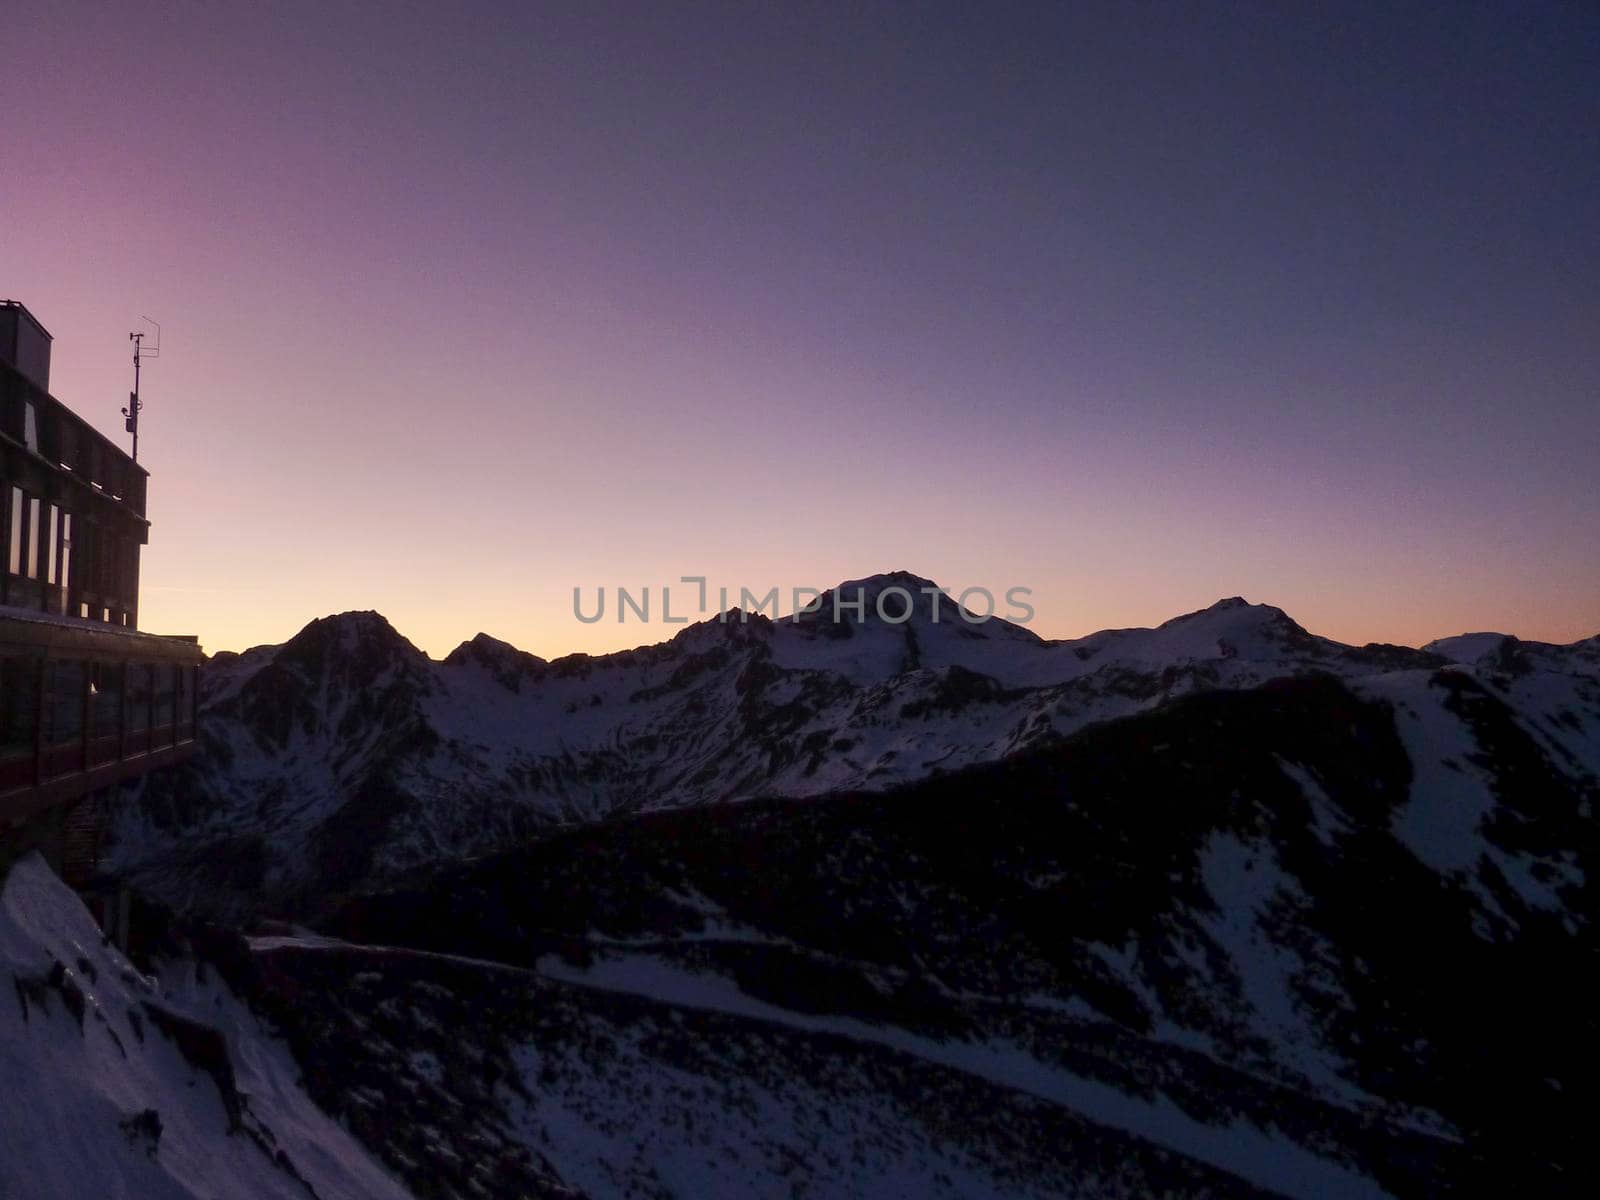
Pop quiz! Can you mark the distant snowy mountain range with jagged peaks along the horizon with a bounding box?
[106,573,1595,912]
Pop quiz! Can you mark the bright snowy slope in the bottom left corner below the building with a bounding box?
[0,854,410,1200]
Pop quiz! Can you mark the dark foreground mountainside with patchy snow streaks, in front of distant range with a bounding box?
[90,667,1600,1197]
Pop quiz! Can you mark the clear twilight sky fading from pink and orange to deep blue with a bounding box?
[0,0,1600,656]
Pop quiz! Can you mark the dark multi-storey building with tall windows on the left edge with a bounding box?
[0,301,203,882]
